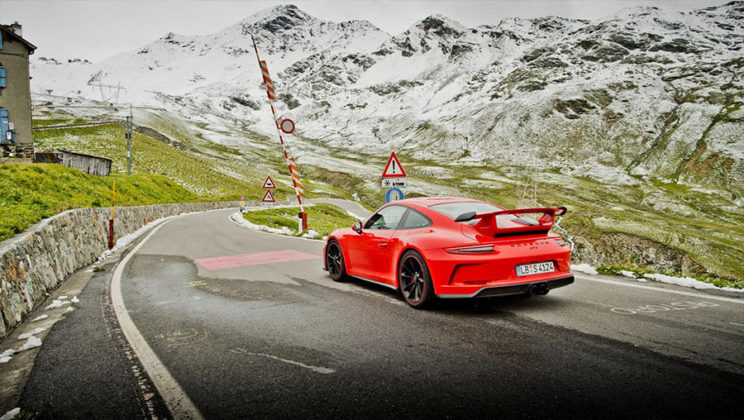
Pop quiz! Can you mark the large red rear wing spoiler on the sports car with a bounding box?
[464,207,567,237]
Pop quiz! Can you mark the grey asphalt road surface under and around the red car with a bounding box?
[14,211,744,418]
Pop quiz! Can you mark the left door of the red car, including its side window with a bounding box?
[348,205,407,284]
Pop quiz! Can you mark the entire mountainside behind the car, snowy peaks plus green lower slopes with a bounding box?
[32,2,744,279]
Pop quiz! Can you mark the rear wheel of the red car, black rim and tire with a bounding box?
[398,250,434,309]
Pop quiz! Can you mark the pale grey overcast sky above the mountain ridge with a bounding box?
[0,0,728,61]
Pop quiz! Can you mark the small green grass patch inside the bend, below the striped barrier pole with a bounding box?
[243,204,356,237]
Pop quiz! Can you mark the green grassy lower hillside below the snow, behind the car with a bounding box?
[27,114,744,286]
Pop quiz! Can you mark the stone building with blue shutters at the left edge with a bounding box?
[0,22,36,158]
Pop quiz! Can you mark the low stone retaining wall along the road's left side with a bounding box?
[0,202,244,339]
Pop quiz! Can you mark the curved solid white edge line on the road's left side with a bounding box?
[111,219,204,420]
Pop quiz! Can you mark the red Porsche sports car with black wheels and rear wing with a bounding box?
[323,197,574,308]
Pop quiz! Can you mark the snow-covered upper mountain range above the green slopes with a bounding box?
[32,1,744,195]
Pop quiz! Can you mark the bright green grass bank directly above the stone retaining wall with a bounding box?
[0,164,204,240]
